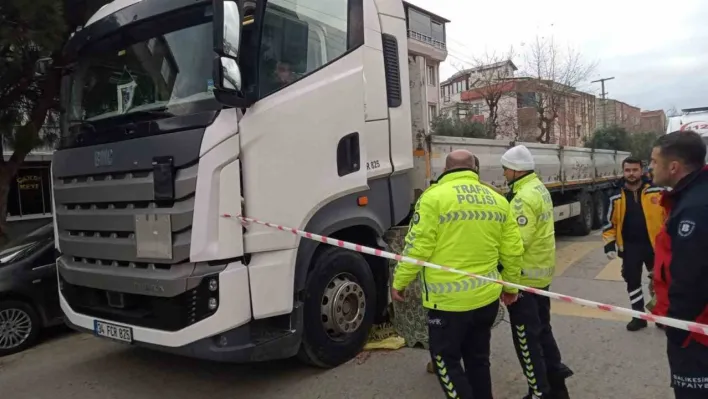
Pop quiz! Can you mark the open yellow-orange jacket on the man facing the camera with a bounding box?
[602,183,666,257]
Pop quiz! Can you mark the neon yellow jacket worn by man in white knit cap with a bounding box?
[502,173,556,288]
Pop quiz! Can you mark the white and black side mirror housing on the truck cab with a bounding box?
[213,0,249,108]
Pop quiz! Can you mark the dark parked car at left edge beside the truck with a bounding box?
[0,223,63,357]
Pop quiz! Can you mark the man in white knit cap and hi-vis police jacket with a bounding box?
[501,145,572,399]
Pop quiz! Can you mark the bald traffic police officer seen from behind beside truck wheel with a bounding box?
[391,150,523,399]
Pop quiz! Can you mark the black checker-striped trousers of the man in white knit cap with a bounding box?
[508,287,572,397]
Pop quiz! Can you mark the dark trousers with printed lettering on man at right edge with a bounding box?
[666,341,708,399]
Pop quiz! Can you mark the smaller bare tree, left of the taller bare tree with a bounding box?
[470,47,517,139]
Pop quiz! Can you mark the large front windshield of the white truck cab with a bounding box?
[68,17,216,125]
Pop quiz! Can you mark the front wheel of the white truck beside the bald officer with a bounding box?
[298,247,376,368]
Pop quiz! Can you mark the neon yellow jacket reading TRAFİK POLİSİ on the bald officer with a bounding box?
[393,169,523,312]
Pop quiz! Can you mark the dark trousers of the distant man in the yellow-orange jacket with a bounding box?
[622,242,654,312]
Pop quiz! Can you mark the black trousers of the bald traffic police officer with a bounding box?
[428,301,499,399]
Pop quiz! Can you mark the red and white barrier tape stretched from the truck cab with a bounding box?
[222,215,708,335]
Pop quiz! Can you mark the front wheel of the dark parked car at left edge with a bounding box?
[0,300,41,357]
